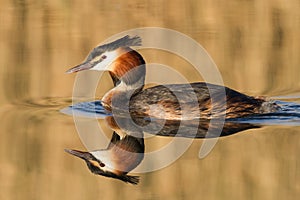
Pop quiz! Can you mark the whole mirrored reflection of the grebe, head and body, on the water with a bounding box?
[65,116,259,184]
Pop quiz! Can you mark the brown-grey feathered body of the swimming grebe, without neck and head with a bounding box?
[130,82,265,119]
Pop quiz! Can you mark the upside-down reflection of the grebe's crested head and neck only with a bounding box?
[65,132,145,184]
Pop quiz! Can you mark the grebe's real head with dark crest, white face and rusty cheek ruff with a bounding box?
[67,35,145,84]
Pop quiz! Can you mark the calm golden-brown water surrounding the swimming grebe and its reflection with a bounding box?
[0,0,300,200]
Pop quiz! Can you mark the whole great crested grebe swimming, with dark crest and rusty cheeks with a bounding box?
[67,35,279,120]
